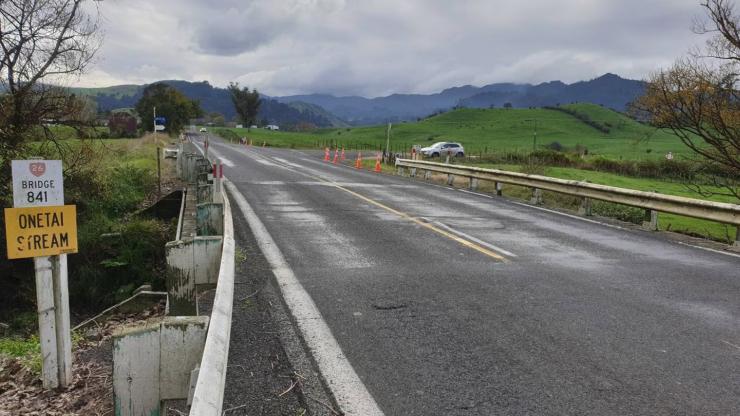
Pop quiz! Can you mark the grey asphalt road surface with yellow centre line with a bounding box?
[199,135,740,415]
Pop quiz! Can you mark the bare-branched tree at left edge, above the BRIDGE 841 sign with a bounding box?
[0,0,100,195]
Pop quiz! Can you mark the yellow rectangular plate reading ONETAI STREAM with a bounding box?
[5,205,77,259]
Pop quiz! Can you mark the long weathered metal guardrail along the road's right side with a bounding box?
[396,159,740,226]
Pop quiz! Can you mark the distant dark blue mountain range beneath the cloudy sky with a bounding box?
[72,74,645,127]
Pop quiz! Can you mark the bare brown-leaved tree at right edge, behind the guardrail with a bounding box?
[632,0,740,199]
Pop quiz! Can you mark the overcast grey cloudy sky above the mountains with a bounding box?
[73,0,702,96]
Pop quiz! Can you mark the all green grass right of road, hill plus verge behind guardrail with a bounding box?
[212,104,737,241]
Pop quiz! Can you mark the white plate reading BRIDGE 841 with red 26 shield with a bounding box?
[11,160,64,208]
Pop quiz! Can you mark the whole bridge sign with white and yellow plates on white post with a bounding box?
[5,160,77,389]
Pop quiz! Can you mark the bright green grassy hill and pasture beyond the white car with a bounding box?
[207,104,690,160]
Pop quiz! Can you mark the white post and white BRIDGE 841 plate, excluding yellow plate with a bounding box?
[11,160,72,388]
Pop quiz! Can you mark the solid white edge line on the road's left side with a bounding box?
[224,180,384,416]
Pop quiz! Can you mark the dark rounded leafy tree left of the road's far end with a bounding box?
[136,82,203,134]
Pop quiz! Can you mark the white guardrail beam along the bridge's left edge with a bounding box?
[190,164,235,416]
